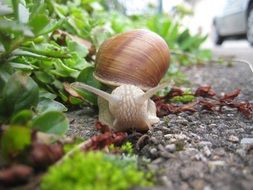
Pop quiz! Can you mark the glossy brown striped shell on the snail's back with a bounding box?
[94,29,170,90]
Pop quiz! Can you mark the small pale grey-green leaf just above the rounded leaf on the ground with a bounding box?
[36,98,68,114]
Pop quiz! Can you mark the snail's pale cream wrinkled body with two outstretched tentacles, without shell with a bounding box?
[72,82,171,131]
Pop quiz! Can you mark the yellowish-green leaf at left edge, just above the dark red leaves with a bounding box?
[1,126,31,158]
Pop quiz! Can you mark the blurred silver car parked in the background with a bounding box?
[212,0,253,46]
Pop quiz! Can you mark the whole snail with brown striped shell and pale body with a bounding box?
[72,29,172,131]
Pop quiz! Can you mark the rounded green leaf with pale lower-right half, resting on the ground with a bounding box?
[32,111,69,135]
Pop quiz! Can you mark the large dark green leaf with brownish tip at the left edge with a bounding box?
[0,72,39,116]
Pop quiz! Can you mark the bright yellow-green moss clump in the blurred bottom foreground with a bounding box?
[41,152,152,190]
